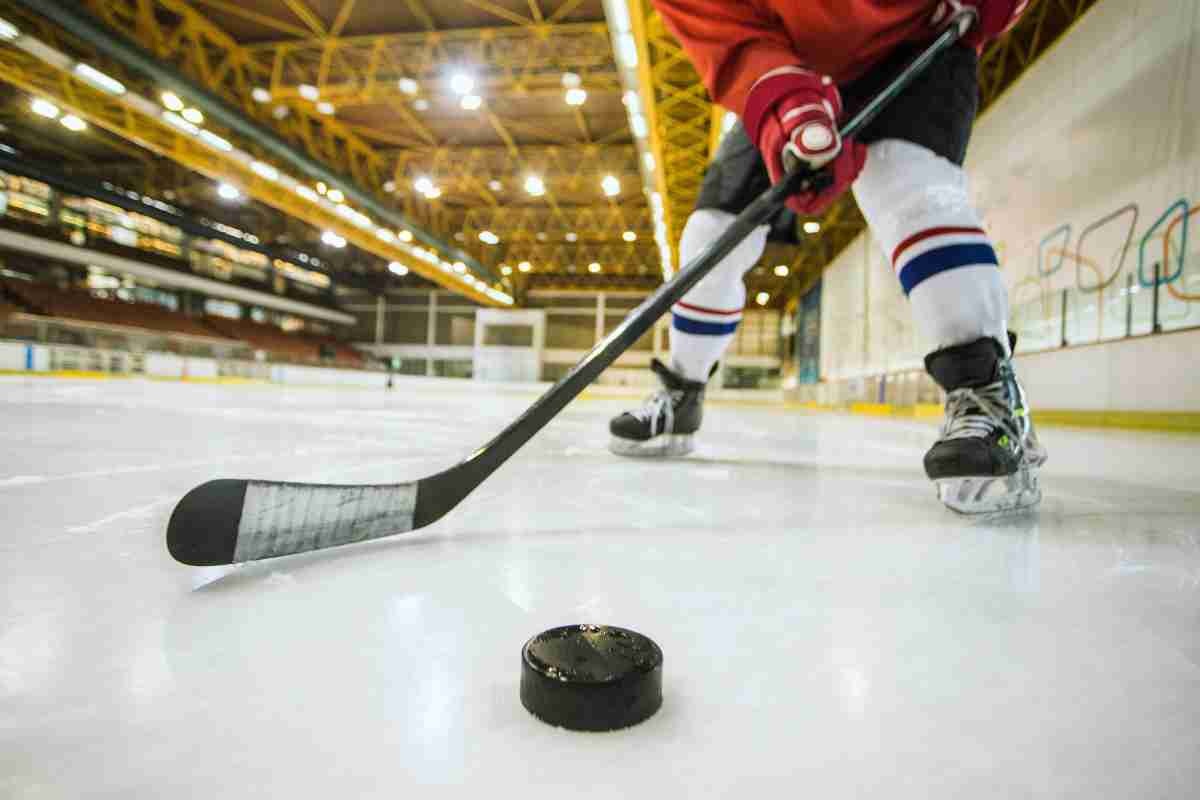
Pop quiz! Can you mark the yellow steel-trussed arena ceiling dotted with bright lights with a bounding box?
[0,0,1096,305]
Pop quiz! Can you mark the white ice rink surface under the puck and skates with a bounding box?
[0,378,1200,800]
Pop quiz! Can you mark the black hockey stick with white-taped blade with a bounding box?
[167,14,971,566]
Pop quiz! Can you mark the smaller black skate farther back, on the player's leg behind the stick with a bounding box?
[608,359,704,457]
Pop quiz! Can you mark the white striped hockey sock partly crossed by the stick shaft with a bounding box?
[671,209,768,381]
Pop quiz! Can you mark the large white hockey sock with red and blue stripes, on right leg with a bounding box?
[854,139,1008,353]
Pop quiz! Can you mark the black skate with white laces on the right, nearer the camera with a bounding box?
[925,336,1046,513]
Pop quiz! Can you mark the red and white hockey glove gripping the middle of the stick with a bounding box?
[743,67,866,215]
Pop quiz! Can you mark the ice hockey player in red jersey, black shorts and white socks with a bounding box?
[610,0,1045,513]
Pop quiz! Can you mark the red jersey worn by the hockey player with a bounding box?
[654,0,938,116]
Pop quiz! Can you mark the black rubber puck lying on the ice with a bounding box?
[521,625,662,730]
